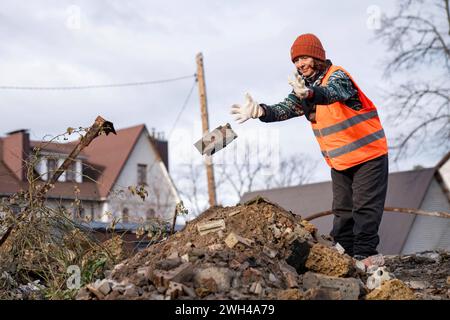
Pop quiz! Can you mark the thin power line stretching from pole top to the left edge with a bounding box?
[0,74,195,90]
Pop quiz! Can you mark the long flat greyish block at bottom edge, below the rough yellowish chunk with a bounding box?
[303,272,360,300]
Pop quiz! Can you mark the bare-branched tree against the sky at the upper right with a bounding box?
[376,0,450,160]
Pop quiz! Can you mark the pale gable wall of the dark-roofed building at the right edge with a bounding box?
[402,179,450,254]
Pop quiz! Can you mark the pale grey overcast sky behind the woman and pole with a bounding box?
[0,0,443,192]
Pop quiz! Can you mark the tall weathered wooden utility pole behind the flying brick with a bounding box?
[195,52,217,207]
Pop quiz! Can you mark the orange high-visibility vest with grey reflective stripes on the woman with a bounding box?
[311,65,388,170]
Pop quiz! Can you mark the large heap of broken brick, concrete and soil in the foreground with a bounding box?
[77,198,448,300]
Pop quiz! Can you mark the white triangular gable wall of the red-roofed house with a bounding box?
[107,133,176,223]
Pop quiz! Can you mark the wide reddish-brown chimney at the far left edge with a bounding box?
[2,129,30,181]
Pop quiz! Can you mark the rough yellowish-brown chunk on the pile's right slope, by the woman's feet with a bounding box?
[306,244,353,277]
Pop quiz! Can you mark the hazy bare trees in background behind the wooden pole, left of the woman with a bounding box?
[175,141,317,215]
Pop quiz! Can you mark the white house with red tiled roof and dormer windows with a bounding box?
[0,125,179,223]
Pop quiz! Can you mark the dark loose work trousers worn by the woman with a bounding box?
[330,154,389,256]
